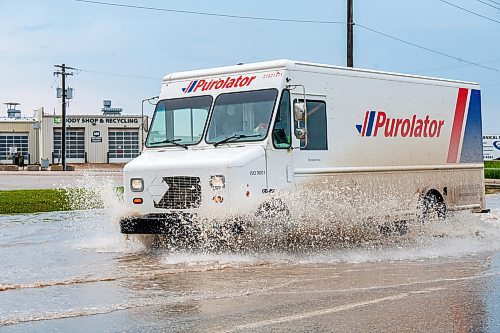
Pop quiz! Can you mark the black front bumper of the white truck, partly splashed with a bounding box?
[120,213,193,234]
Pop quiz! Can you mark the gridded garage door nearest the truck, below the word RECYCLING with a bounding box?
[108,129,139,159]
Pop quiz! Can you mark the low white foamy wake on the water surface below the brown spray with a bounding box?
[152,206,500,270]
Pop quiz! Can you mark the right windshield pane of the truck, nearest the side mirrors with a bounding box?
[207,89,278,144]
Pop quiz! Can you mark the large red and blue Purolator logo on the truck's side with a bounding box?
[356,111,444,138]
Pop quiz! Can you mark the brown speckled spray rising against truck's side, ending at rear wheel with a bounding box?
[136,183,414,252]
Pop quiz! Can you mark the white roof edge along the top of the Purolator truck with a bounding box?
[163,59,478,86]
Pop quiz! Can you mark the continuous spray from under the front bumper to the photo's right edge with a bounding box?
[133,185,500,258]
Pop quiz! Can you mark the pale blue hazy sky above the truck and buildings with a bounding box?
[0,0,500,134]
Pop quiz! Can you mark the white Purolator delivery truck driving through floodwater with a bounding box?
[121,60,485,234]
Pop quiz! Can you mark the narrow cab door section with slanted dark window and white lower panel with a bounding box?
[266,89,294,193]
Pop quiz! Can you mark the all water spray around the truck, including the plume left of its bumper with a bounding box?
[61,172,500,260]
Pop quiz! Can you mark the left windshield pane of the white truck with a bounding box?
[146,96,212,147]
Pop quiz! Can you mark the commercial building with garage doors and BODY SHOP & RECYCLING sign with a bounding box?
[0,101,148,164]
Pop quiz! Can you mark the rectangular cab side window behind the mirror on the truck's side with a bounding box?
[294,99,328,150]
